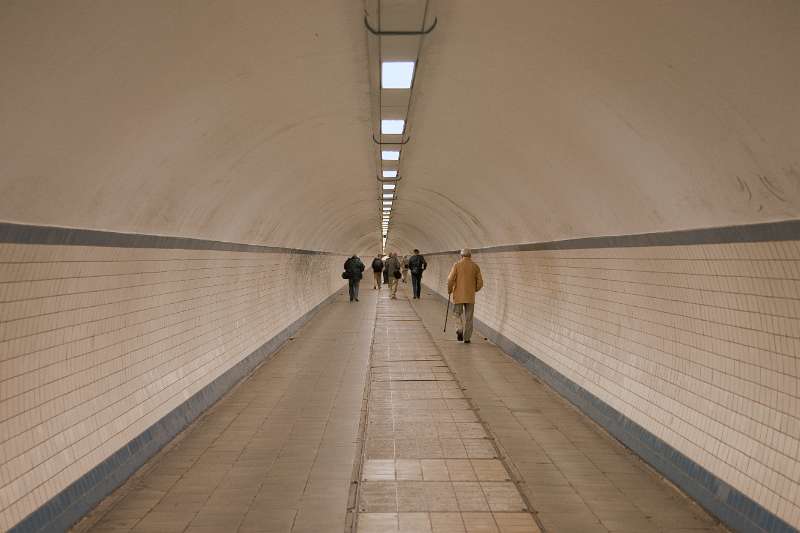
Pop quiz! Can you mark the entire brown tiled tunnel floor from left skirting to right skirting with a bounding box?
[75,286,724,533]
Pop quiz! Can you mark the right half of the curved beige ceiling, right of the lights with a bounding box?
[387,0,800,254]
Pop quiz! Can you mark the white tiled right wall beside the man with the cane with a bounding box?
[425,242,800,526]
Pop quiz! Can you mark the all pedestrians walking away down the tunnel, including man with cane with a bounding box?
[342,248,483,344]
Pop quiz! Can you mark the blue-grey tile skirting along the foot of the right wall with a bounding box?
[427,287,798,533]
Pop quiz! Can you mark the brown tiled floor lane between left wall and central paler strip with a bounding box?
[75,290,376,533]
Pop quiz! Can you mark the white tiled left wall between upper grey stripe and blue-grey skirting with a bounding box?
[0,244,344,530]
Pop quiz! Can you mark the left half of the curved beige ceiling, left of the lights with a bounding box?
[0,0,379,251]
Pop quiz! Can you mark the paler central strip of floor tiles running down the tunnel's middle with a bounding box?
[357,295,539,533]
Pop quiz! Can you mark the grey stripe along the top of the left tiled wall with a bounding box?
[0,222,338,256]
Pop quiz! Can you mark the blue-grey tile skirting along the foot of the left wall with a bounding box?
[9,290,340,533]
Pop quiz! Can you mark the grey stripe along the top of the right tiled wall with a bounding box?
[425,220,800,256]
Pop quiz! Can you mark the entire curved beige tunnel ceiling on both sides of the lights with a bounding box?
[0,0,800,253]
